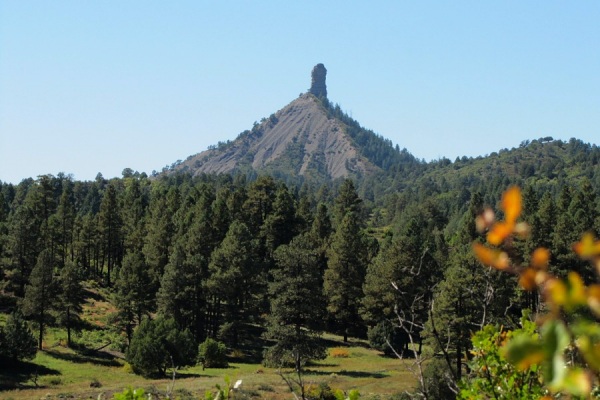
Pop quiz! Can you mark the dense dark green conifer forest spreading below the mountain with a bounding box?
[0,136,600,398]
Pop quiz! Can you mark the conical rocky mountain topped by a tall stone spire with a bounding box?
[169,64,410,181]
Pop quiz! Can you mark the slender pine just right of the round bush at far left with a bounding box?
[22,250,56,350]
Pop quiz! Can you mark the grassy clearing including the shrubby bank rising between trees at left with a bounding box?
[0,288,416,400]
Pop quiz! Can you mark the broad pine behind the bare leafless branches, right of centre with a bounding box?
[361,209,444,353]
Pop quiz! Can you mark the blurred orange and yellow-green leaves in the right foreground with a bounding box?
[473,187,600,397]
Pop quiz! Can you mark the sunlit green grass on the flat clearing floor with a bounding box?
[0,336,415,399]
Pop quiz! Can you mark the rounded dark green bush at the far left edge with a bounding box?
[0,311,37,362]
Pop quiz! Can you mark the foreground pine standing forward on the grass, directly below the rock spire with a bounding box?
[265,236,326,371]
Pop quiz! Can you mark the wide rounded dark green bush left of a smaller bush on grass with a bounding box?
[126,317,197,376]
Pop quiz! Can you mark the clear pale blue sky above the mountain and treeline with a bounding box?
[0,0,600,183]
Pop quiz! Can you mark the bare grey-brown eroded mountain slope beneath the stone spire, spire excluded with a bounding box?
[179,93,373,179]
